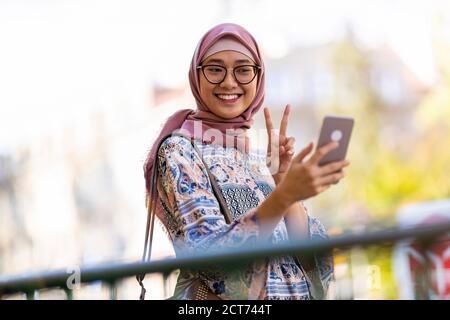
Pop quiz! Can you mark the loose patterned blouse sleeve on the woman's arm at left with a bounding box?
[158,136,266,299]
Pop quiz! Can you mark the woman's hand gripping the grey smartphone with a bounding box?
[276,142,350,204]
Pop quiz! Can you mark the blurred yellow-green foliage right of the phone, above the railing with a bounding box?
[320,32,450,225]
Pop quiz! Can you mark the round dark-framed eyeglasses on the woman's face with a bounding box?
[197,64,261,84]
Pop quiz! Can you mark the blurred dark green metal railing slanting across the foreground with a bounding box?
[0,223,450,299]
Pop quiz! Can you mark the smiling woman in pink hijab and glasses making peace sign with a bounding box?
[144,23,348,299]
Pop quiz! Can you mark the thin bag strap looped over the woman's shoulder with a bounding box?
[136,132,233,300]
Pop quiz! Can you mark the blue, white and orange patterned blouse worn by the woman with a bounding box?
[157,136,333,300]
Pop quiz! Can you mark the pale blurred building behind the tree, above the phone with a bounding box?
[266,43,429,144]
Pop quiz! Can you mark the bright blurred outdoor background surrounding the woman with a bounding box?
[0,0,450,299]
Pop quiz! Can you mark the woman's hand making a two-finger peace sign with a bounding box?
[264,105,295,185]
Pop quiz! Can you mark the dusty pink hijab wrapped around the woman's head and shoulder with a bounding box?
[144,23,265,194]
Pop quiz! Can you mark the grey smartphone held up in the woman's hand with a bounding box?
[317,116,354,166]
